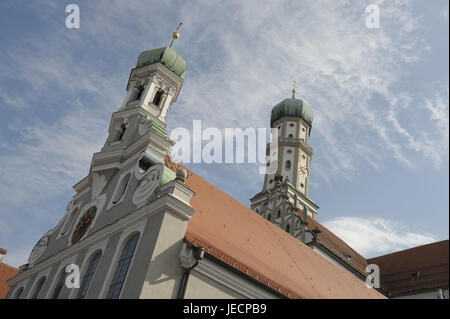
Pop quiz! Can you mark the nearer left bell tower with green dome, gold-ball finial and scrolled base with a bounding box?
[69,24,187,219]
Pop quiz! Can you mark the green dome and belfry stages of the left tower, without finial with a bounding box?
[102,47,186,151]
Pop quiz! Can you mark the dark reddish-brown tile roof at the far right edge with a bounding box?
[367,240,449,295]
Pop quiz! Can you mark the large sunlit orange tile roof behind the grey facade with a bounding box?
[165,159,385,298]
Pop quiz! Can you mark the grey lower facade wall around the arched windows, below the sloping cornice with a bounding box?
[8,186,192,298]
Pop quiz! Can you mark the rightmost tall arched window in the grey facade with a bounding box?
[107,234,139,299]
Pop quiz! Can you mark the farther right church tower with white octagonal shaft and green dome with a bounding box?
[250,82,319,239]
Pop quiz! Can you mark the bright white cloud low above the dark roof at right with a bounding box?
[323,216,436,258]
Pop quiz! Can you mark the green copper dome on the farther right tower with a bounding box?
[270,98,314,126]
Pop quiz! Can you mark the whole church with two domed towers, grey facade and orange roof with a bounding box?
[7,39,448,299]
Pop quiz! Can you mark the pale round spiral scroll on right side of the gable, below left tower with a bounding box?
[133,164,164,206]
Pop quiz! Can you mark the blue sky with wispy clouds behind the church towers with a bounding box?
[0,0,449,266]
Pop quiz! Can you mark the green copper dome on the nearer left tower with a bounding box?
[136,47,187,79]
